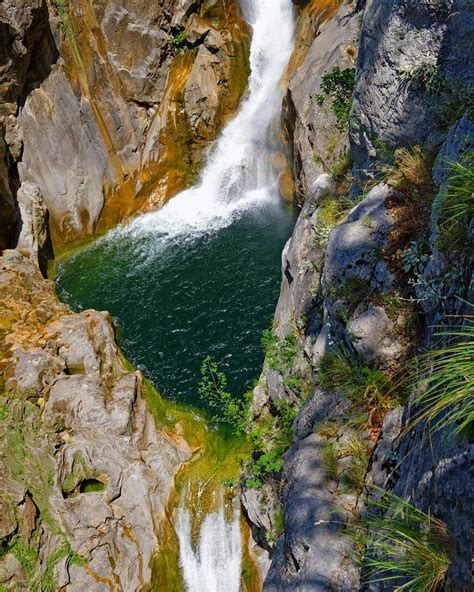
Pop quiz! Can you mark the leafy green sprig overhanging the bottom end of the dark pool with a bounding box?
[198,356,249,433]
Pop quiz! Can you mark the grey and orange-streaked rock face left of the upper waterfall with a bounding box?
[0,0,249,252]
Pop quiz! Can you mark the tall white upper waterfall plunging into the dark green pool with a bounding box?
[115,0,294,248]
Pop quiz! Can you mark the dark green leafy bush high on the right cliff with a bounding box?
[314,66,356,132]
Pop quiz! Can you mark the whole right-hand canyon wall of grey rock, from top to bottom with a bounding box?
[243,0,474,592]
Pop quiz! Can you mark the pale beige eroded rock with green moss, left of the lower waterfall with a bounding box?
[0,251,190,591]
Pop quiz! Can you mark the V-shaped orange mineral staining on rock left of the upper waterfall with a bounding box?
[51,0,250,250]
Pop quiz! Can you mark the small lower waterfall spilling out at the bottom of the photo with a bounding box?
[176,498,242,592]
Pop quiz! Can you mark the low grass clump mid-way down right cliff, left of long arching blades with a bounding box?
[319,352,396,411]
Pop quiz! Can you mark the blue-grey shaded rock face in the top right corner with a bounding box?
[351,0,474,174]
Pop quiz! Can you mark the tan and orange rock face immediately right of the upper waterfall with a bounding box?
[283,1,362,200]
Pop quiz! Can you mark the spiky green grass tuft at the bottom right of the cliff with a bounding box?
[350,490,450,592]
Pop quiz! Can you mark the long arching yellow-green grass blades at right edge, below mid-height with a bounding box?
[409,317,474,433]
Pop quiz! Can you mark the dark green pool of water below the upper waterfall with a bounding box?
[57,196,296,404]
